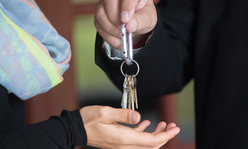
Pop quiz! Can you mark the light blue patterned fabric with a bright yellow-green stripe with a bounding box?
[0,0,71,100]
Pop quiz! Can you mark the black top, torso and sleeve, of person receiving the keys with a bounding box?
[0,85,87,149]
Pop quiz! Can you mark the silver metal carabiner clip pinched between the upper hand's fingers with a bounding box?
[121,24,133,65]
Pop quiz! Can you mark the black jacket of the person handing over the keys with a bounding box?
[96,0,248,149]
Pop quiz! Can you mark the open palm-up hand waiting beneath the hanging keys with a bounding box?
[80,106,180,149]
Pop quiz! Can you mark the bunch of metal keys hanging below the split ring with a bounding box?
[121,74,138,110]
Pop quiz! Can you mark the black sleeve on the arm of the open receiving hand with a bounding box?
[0,110,87,149]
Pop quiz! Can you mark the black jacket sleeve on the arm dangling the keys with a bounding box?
[95,0,197,100]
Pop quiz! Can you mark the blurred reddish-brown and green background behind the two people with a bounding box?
[26,0,195,149]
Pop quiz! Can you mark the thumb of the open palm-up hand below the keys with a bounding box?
[103,108,141,124]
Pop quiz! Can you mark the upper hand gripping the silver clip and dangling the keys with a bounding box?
[94,0,157,50]
